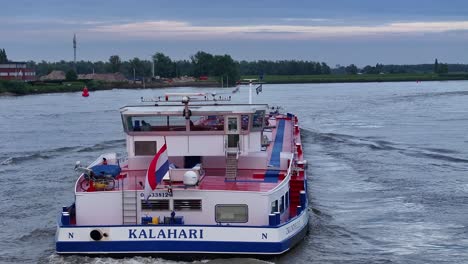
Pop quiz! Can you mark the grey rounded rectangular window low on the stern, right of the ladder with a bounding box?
[215,204,249,223]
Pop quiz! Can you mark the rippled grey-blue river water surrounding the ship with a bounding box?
[0,81,468,263]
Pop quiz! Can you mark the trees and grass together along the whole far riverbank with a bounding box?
[0,49,468,95]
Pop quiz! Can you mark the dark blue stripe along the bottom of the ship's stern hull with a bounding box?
[56,222,308,254]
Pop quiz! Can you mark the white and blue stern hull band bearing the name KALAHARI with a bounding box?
[56,207,309,255]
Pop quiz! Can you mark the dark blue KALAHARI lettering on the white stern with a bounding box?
[128,228,203,239]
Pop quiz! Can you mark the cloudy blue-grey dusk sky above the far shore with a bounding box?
[0,0,468,67]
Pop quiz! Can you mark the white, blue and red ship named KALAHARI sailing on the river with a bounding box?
[56,85,309,255]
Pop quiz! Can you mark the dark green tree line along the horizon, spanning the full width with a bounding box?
[0,49,468,83]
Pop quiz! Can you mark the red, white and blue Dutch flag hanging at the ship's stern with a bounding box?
[145,143,169,199]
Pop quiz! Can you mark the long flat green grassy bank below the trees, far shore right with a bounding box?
[242,74,468,83]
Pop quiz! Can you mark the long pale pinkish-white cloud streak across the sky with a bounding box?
[87,20,468,39]
